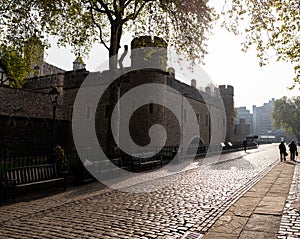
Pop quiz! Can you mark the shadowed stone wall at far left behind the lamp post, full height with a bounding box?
[0,86,71,153]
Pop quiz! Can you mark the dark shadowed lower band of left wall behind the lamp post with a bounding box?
[0,115,72,154]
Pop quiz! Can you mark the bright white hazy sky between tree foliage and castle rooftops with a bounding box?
[46,3,300,110]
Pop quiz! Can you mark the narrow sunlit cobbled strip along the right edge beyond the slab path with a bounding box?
[278,152,300,239]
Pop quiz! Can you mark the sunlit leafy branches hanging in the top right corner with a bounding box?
[223,0,300,88]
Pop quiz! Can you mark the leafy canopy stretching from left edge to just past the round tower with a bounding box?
[0,0,215,70]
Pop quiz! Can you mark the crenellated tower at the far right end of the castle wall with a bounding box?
[219,85,235,142]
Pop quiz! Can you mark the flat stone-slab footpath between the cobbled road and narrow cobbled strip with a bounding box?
[203,162,300,239]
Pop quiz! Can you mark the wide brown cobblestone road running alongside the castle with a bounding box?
[0,145,278,239]
